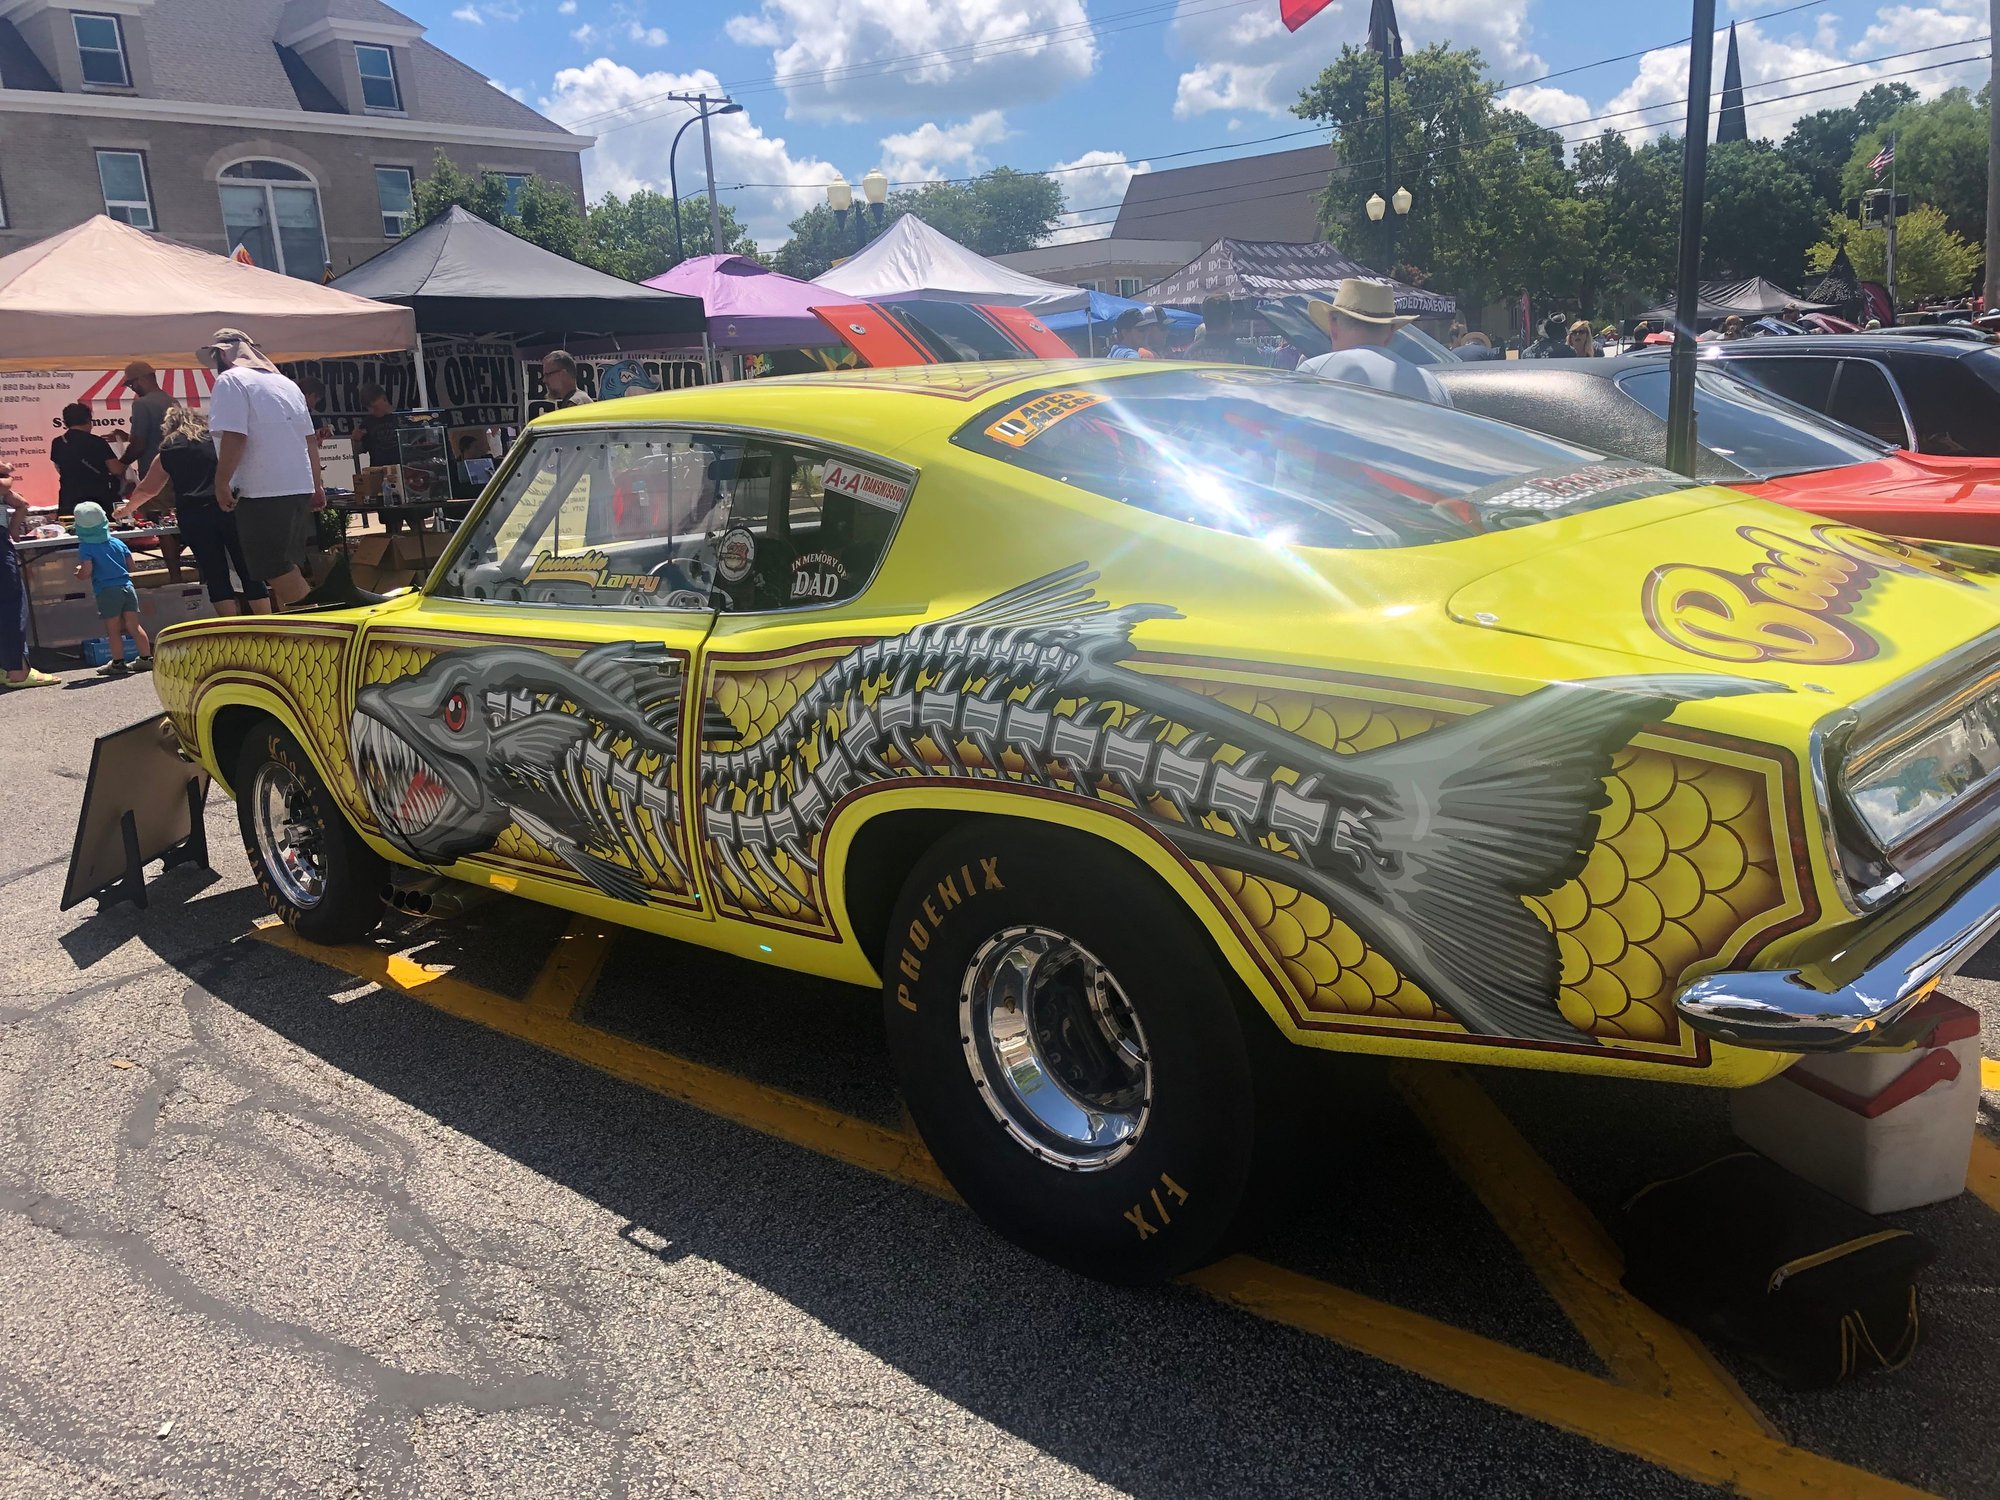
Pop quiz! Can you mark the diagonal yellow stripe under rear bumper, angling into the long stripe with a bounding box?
[1390,1062,1778,1436]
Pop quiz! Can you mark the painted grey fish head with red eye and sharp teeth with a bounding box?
[348,654,512,864]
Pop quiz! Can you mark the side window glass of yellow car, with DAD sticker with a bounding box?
[436,428,914,612]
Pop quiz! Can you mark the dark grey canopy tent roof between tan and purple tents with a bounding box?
[334,206,708,346]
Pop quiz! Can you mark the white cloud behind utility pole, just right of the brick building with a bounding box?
[538,58,838,246]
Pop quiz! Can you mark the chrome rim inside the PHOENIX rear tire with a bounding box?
[958,926,1152,1172]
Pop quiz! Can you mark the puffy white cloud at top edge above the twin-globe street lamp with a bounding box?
[724,0,1098,120]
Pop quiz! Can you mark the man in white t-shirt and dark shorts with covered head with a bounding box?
[194,328,326,610]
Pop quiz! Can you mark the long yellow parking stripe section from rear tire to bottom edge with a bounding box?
[1182,1256,1924,1500]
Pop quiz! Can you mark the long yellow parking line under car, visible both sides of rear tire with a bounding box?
[254,924,1924,1500]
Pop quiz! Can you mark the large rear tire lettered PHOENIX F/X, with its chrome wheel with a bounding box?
[882,822,1256,1282]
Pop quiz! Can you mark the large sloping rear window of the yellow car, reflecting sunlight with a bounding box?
[952,368,1686,548]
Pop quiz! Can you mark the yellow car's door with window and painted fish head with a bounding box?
[350,424,742,930]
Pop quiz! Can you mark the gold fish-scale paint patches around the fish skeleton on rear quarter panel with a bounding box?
[710,654,1804,1048]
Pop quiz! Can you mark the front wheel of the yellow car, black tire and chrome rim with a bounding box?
[236,722,388,944]
